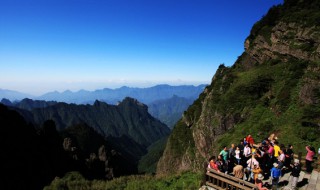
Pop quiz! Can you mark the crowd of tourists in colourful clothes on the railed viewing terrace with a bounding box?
[208,135,315,190]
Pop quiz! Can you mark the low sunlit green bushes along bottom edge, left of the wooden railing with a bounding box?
[44,172,201,190]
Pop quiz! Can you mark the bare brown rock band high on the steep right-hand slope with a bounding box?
[245,22,320,64]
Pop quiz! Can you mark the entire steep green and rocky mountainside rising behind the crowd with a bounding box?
[157,0,320,174]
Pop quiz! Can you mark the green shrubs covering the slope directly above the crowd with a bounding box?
[212,59,320,150]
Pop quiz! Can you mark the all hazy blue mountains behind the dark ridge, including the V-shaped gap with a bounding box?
[0,85,206,128]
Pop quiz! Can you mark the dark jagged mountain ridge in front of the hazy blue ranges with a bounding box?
[13,97,170,146]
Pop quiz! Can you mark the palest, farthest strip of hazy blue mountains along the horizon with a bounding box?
[0,84,206,104]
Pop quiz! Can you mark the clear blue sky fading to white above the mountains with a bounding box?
[0,0,283,95]
